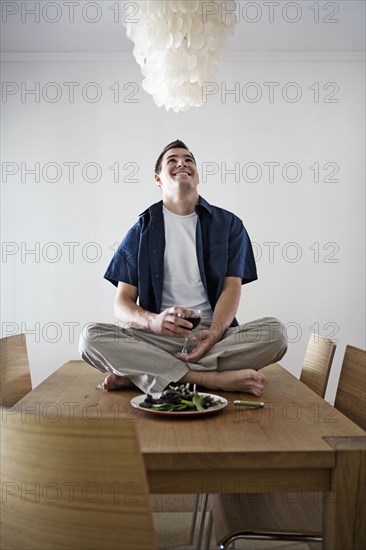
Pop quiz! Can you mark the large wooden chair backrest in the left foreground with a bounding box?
[1,414,157,550]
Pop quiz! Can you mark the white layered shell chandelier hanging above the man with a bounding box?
[124,0,236,112]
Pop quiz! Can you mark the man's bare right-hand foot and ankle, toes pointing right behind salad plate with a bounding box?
[180,369,264,397]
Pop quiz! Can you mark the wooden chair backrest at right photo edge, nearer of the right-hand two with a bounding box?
[334,346,366,430]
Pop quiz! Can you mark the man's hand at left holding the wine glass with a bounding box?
[149,306,196,338]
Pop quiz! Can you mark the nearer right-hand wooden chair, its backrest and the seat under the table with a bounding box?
[206,346,366,548]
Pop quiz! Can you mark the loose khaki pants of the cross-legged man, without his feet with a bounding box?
[79,317,287,393]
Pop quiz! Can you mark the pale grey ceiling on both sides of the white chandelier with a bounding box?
[1,0,365,54]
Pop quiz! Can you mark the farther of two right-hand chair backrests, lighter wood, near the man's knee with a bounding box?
[300,333,337,397]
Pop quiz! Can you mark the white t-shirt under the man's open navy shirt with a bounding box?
[162,206,212,324]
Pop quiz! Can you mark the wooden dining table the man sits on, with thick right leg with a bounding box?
[10,361,366,550]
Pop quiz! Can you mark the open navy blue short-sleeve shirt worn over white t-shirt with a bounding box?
[104,197,257,326]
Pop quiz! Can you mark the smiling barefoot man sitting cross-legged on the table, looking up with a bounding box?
[80,140,287,396]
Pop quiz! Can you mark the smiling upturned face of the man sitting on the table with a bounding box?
[155,148,199,190]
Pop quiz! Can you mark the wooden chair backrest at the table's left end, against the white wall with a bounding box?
[0,334,32,406]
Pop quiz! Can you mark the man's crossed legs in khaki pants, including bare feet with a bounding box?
[80,317,287,396]
